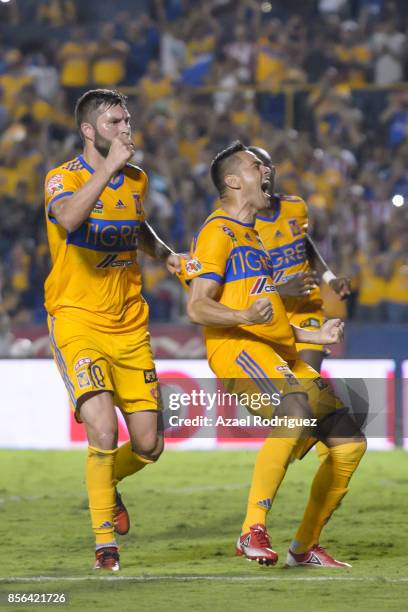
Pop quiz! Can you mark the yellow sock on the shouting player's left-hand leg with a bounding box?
[242,438,297,533]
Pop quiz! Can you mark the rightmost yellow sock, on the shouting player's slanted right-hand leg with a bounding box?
[291,442,366,553]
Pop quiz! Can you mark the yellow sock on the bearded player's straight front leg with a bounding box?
[86,446,118,545]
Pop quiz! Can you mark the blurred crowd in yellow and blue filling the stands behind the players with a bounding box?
[0,0,408,332]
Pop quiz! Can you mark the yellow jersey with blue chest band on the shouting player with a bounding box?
[185,208,297,360]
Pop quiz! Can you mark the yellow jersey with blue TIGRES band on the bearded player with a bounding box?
[45,155,148,333]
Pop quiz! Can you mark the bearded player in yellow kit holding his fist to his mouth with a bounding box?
[45,89,180,571]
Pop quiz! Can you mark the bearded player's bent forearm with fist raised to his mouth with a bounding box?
[51,134,134,232]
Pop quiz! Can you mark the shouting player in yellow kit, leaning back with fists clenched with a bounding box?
[186,142,366,568]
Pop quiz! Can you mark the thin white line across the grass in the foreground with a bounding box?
[0,570,408,585]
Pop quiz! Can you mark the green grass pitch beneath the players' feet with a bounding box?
[0,451,408,612]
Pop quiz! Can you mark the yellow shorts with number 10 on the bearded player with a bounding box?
[48,314,161,422]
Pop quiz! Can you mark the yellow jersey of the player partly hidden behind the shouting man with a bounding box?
[255,195,321,315]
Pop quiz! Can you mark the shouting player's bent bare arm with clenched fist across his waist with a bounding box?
[187,278,273,327]
